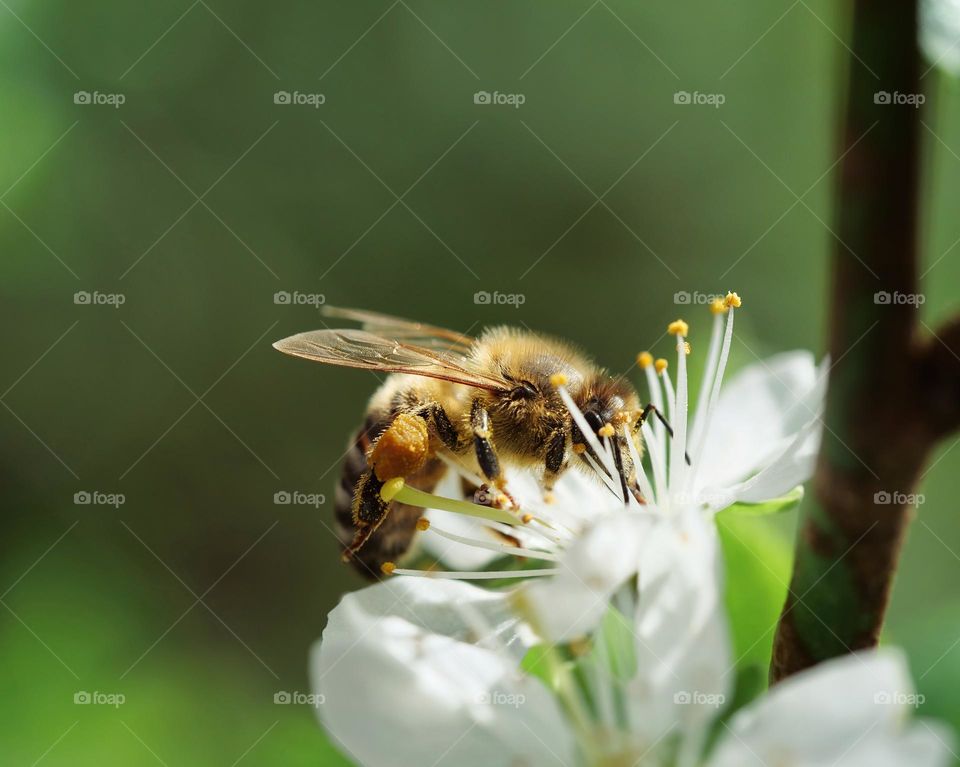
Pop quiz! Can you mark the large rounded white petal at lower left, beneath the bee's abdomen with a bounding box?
[311,577,575,767]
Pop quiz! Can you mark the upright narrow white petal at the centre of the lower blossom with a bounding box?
[630,513,733,746]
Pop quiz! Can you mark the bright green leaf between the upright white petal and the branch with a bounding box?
[716,512,793,670]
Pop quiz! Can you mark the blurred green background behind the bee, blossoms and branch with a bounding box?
[0,0,960,767]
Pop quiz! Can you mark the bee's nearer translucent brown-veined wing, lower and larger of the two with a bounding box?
[273,330,509,391]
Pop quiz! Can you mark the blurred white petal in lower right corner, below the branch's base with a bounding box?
[709,650,949,767]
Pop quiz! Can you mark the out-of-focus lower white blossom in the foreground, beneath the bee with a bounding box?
[312,514,951,767]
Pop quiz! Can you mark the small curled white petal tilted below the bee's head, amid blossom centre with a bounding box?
[523,506,648,642]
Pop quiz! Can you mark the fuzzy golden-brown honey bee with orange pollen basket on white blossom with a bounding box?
[273,307,672,578]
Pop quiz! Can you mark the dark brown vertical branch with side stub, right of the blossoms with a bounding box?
[771,0,960,681]
